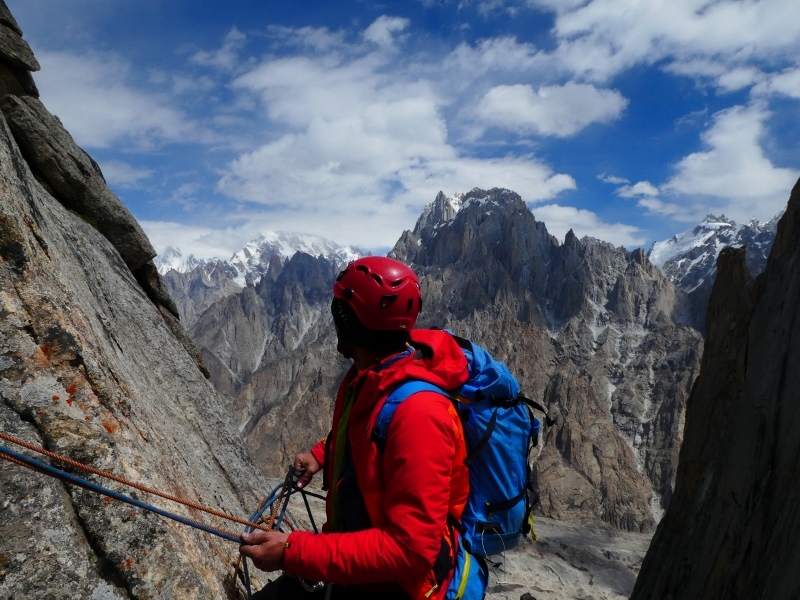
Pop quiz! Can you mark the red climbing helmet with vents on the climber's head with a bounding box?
[333,256,422,331]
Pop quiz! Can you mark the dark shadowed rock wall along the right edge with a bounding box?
[632,176,800,599]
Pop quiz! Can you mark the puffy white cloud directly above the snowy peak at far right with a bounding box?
[661,103,800,222]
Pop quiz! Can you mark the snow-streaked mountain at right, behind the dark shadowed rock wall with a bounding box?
[647,214,781,293]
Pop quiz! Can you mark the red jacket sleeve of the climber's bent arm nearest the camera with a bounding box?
[283,392,460,584]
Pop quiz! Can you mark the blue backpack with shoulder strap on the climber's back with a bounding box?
[372,332,552,600]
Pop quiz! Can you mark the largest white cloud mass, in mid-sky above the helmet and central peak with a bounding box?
[219,21,575,247]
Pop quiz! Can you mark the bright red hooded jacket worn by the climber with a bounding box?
[283,330,469,600]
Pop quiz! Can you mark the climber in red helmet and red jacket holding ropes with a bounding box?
[240,256,469,600]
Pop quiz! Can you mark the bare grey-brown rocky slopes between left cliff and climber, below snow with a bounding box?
[190,253,348,466]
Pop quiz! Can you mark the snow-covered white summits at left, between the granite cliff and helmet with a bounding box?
[153,231,363,287]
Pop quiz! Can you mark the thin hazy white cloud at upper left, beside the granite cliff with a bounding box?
[36,51,207,148]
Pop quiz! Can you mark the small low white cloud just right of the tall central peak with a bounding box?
[533,204,647,248]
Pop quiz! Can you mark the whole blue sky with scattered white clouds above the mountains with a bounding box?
[5,0,800,258]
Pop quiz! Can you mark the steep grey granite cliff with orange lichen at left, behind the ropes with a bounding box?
[0,0,267,600]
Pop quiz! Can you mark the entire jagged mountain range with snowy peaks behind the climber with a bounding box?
[156,189,777,530]
